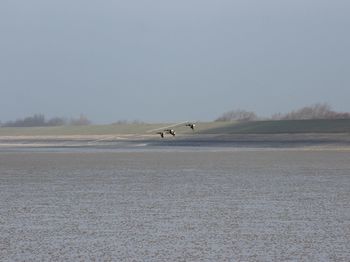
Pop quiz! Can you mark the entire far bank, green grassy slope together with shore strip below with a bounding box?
[0,120,350,148]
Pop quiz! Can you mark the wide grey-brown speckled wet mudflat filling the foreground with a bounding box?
[0,148,350,261]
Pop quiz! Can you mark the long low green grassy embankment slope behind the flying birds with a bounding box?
[0,119,350,136]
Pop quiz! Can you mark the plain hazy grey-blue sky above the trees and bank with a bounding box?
[0,0,350,124]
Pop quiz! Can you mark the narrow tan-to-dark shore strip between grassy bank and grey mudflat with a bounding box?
[0,133,350,151]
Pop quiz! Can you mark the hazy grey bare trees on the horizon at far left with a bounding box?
[0,114,91,127]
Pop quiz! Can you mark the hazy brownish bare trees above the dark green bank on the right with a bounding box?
[215,103,350,122]
